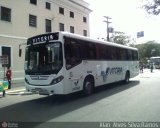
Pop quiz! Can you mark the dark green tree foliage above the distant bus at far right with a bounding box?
[136,41,160,62]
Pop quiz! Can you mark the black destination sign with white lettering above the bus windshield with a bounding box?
[27,33,59,45]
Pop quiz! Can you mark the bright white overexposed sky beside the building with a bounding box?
[85,0,160,43]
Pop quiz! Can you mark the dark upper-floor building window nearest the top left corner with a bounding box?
[1,7,11,22]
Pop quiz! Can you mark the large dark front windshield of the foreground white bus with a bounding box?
[25,42,63,75]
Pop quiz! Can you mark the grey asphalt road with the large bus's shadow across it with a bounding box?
[0,70,160,127]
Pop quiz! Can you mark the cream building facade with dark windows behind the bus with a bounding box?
[0,0,91,81]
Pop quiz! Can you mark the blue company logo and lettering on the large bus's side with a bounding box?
[101,67,122,82]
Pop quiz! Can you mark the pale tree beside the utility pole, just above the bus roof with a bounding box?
[110,31,130,45]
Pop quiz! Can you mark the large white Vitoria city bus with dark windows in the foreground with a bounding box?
[21,32,139,95]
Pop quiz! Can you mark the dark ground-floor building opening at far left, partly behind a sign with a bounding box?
[2,46,11,67]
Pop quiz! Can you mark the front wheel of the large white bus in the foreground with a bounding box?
[83,78,94,96]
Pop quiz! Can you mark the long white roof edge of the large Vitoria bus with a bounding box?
[60,32,138,50]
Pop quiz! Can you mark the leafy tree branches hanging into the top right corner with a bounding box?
[143,0,160,15]
